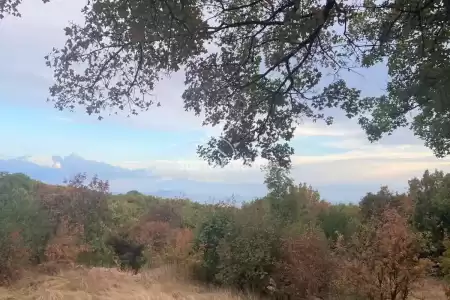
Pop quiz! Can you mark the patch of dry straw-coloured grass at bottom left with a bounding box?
[0,267,256,300]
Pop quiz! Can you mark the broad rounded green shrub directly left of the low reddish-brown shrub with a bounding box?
[215,206,280,292]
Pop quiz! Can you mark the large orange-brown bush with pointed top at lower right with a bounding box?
[336,208,430,300]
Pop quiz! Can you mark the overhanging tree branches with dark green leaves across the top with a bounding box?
[2,0,450,166]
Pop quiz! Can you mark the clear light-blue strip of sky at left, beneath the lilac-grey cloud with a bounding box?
[0,101,205,162]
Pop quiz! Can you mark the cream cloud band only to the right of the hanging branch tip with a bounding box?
[292,149,450,185]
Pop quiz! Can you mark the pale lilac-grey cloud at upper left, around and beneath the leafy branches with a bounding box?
[0,0,216,135]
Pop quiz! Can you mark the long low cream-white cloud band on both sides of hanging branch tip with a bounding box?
[107,145,450,189]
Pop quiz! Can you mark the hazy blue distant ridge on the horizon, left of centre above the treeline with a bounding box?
[0,154,265,202]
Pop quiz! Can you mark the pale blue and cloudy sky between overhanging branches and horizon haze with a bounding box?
[0,0,450,201]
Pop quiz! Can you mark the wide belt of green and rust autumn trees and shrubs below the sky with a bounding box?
[0,166,450,300]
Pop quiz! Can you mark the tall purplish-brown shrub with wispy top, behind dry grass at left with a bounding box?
[35,174,112,265]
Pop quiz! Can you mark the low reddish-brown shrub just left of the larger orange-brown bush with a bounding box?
[273,229,334,299]
